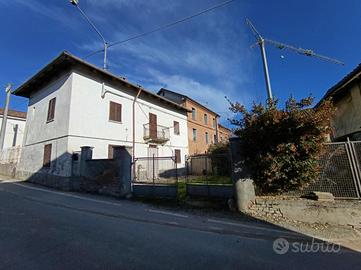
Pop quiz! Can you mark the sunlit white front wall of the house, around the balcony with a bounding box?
[68,73,188,165]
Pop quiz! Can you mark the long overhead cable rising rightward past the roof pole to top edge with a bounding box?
[84,0,237,59]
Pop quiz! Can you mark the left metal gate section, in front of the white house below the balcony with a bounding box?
[133,156,178,184]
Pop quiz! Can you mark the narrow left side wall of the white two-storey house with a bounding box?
[17,74,72,176]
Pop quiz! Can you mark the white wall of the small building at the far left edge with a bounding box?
[0,115,26,148]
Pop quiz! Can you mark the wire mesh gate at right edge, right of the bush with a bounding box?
[304,142,361,199]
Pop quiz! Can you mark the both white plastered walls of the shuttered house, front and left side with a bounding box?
[17,69,188,176]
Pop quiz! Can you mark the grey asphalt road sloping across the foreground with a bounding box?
[0,182,361,270]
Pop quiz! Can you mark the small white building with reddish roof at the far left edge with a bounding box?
[0,108,26,149]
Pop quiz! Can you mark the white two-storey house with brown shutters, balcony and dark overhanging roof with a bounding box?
[14,52,188,182]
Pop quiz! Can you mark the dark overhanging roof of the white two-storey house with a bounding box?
[13,51,188,112]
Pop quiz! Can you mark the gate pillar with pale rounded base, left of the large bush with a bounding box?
[229,137,256,212]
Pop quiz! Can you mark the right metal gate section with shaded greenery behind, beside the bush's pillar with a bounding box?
[186,154,232,184]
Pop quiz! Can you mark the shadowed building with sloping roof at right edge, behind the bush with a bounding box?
[316,64,361,141]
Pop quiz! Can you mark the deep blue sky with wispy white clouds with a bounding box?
[0,0,361,125]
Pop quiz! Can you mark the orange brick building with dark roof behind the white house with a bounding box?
[158,88,231,155]
